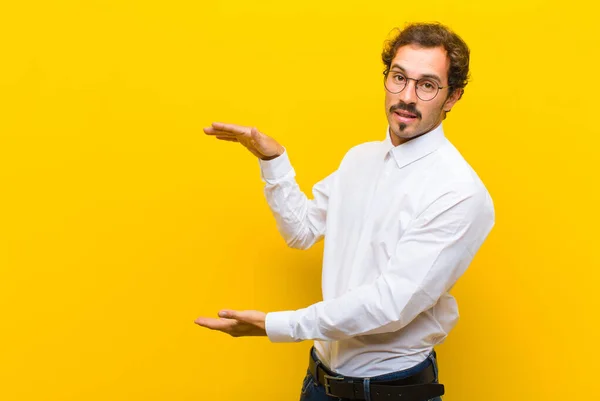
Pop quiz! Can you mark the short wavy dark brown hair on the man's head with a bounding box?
[381,23,470,96]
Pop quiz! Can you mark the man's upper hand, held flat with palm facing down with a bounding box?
[204,123,284,160]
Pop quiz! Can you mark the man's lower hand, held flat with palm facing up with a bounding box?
[194,309,267,337]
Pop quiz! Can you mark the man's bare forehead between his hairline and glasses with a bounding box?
[391,45,450,81]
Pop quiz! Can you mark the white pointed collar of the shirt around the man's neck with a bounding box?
[382,124,447,168]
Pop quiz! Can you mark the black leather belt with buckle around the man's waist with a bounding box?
[308,355,444,401]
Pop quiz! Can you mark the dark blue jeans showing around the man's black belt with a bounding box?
[300,348,442,401]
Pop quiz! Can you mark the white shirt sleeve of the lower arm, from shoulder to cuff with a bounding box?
[266,183,494,342]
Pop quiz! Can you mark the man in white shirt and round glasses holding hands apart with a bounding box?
[196,24,494,401]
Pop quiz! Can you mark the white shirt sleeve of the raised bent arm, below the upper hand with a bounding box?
[259,150,335,249]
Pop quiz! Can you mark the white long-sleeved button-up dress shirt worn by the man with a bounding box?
[259,124,494,377]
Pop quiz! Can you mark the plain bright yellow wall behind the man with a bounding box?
[0,0,600,401]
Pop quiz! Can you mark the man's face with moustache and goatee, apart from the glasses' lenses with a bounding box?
[385,45,462,146]
